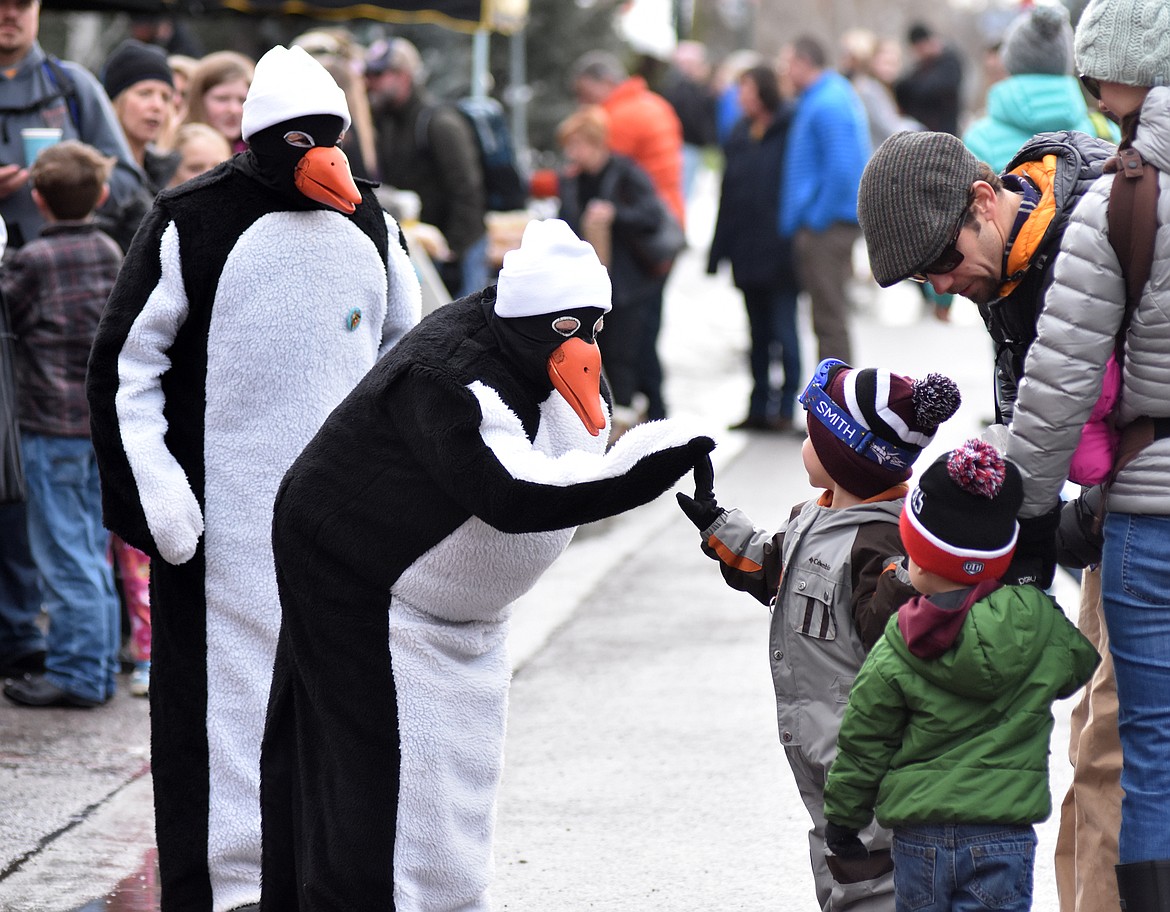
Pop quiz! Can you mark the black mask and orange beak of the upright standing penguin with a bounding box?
[234,114,362,215]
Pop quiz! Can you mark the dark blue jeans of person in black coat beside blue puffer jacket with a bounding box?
[741,286,800,418]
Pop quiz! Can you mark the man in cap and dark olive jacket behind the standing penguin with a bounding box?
[365,37,487,297]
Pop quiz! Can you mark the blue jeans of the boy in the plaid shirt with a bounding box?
[21,433,121,701]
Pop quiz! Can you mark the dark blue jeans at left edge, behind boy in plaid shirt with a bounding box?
[0,503,44,665]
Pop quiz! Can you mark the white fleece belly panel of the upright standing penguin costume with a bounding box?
[204,211,386,912]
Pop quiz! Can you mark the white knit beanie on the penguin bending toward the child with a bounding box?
[495,219,613,317]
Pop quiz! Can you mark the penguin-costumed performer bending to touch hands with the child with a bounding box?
[261,220,714,912]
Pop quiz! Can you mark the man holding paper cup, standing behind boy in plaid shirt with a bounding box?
[0,0,143,693]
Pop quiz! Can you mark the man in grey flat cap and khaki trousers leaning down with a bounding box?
[858,131,1121,912]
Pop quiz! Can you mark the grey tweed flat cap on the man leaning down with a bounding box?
[858,132,979,288]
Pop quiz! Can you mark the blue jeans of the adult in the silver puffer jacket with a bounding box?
[1101,513,1170,864]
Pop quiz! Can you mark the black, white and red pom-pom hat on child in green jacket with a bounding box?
[899,440,1024,584]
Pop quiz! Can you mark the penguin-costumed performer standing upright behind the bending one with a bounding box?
[88,47,420,912]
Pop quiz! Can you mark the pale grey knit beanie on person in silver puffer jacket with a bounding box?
[1076,0,1170,87]
